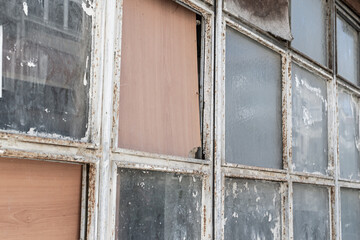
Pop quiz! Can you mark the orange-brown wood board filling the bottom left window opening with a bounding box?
[0,158,82,240]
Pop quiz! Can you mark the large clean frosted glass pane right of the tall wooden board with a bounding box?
[225,28,282,168]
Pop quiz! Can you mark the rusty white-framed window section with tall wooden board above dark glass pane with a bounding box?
[111,0,213,239]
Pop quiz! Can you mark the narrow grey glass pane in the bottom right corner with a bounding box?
[341,188,360,240]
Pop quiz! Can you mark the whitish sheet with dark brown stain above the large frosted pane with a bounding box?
[224,0,292,41]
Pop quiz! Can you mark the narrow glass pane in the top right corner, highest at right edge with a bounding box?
[336,16,360,85]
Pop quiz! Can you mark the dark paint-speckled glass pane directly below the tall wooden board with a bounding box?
[117,169,202,240]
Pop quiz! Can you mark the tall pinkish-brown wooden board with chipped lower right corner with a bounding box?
[118,0,201,157]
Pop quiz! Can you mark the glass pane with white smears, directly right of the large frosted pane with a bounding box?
[292,64,328,174]
